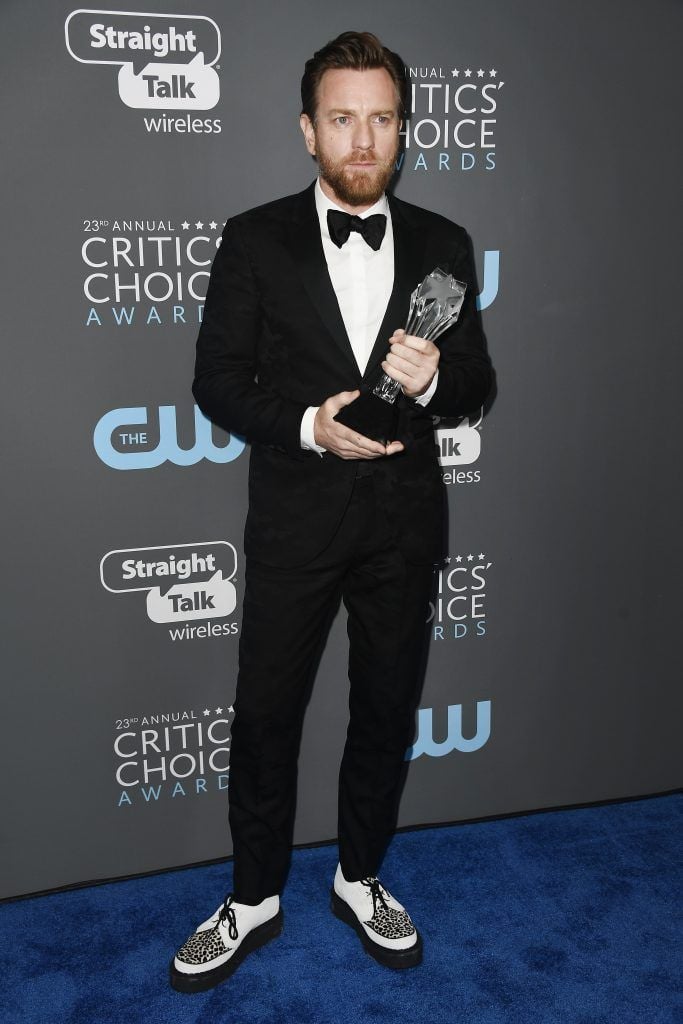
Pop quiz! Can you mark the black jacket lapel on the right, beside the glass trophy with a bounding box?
[364,196,426,380]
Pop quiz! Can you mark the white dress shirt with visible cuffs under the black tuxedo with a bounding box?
[301,178,436,455]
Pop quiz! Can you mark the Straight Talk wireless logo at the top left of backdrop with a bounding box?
[65,8,221,134]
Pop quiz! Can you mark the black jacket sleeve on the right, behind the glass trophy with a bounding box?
[424,228,493,417]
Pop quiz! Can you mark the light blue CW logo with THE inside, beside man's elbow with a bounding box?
[93,406,245,469]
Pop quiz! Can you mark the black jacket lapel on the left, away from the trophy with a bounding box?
[288,185,358,374]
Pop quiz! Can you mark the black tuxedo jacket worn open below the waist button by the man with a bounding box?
[193,185,490,567]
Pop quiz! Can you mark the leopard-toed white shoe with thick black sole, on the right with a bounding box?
[332,865,422,969]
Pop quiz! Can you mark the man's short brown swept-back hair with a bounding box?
[301,32,408,121]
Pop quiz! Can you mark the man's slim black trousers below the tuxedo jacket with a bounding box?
[229,464,433,903]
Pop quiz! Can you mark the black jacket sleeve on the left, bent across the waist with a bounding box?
[193,220,306,457]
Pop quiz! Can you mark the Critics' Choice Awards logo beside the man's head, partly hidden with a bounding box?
[398,65,505,172]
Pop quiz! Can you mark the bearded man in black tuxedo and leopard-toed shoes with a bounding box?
[171,33,490,991]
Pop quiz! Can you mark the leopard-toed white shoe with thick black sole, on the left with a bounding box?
[171,893,284,992]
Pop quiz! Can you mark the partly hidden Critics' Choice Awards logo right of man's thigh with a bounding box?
[427,552,494,640]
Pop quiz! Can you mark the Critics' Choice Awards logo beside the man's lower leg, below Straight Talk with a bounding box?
[114,707,233,807]
